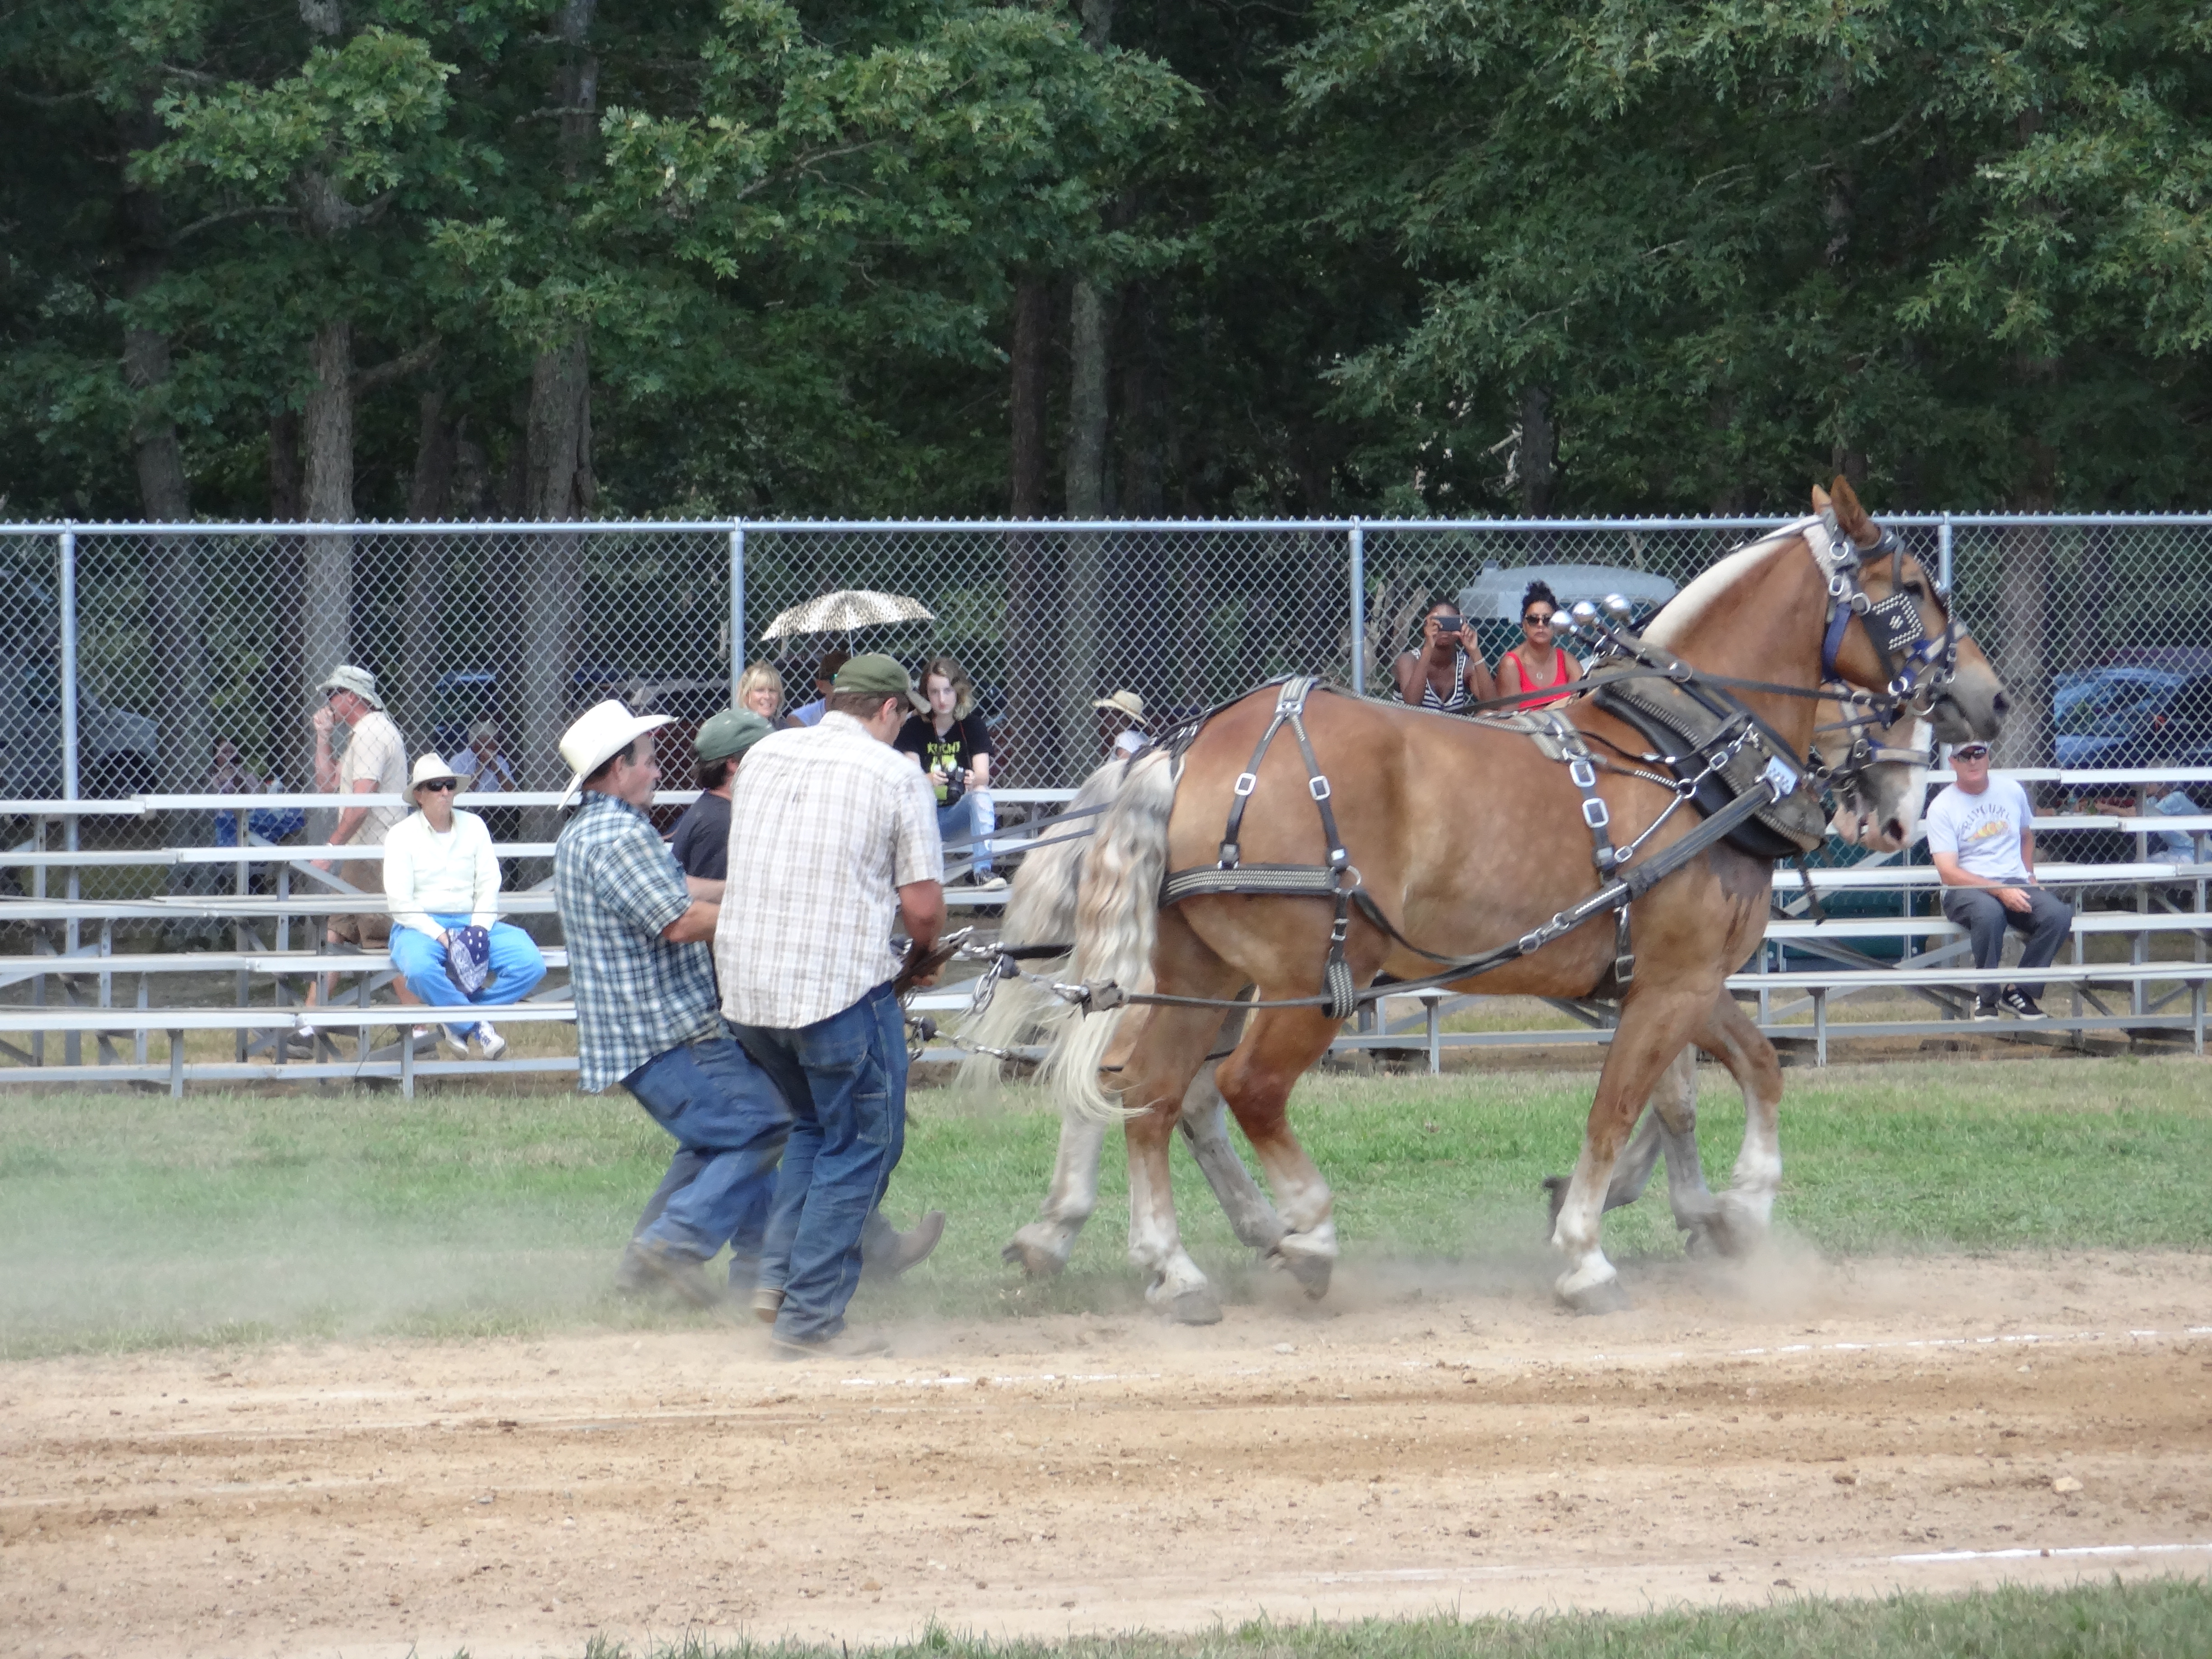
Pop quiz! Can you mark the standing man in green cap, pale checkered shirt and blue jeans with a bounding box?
[714,655,945,1358]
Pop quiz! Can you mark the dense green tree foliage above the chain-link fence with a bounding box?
[0,0,2212,516]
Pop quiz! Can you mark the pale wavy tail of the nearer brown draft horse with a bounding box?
[1046,752,1175,1119]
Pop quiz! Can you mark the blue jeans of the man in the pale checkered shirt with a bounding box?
[734,982,907,1343]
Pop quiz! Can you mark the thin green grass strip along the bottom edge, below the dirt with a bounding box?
[557,1579,2212,1659]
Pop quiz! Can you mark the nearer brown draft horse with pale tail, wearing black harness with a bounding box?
[1017,478,2004,1318]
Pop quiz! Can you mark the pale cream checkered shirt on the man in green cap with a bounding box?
[714,714,945,1031]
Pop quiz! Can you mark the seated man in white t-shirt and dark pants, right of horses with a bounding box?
[1922,743,2073,1020]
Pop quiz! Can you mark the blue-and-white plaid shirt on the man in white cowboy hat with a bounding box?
[553,790,721,1095]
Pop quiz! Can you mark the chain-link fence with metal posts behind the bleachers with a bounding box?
[0,506,2212,818]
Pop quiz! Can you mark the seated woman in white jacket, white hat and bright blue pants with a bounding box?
[385,755,546,1059]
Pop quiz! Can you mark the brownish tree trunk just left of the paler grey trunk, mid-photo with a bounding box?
[998,281,1064,787]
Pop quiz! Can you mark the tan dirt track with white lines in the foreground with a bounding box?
[0,1254,2212,1659]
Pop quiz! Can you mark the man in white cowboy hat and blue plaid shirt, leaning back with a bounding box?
[553,701,790,1308]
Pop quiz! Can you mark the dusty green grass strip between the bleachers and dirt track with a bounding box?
[0,1059,2212,1356]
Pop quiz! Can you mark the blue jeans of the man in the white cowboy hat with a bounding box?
[622,1037,792,1261]
